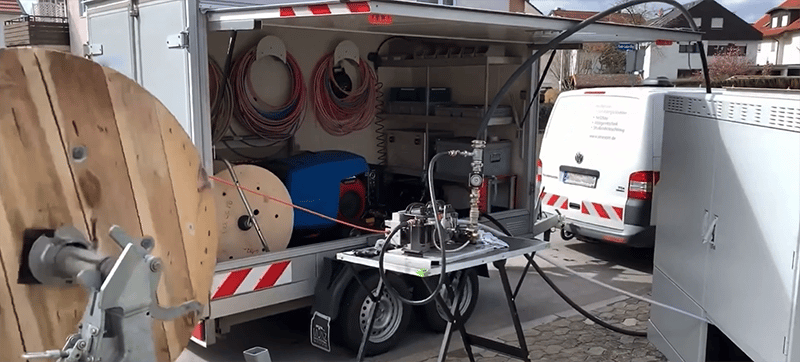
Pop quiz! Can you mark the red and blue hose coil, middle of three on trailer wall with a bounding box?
[231,47,307,141]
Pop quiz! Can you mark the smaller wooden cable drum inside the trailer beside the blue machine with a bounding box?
[214,165,294,261]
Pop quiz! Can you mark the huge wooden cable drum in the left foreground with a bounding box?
[0,48,217,361]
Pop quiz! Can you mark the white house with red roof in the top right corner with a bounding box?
[753,0,800,76]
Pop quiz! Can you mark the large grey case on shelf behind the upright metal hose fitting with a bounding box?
[434,137,511,181]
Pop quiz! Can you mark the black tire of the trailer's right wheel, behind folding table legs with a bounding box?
[414,269,480,333]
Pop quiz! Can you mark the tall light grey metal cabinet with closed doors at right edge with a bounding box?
[648,89,800,361]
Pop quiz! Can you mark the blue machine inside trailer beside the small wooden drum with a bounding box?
[267,151,369,231]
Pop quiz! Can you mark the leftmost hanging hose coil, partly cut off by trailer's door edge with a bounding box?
[208,57,233,143]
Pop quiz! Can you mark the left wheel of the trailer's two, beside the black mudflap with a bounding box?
[337,273,412,356]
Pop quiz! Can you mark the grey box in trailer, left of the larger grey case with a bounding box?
[386,128,453,175]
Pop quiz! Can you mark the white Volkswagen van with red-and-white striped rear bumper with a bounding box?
[538,87,702,247]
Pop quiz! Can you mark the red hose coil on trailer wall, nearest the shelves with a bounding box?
[311,53,378,136]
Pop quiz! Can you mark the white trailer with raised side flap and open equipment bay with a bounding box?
[85,0,700,354]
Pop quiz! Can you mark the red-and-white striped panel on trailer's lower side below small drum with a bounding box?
[211,260,292,300]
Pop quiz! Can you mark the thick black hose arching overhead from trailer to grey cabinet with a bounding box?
[476,0,711,140]
